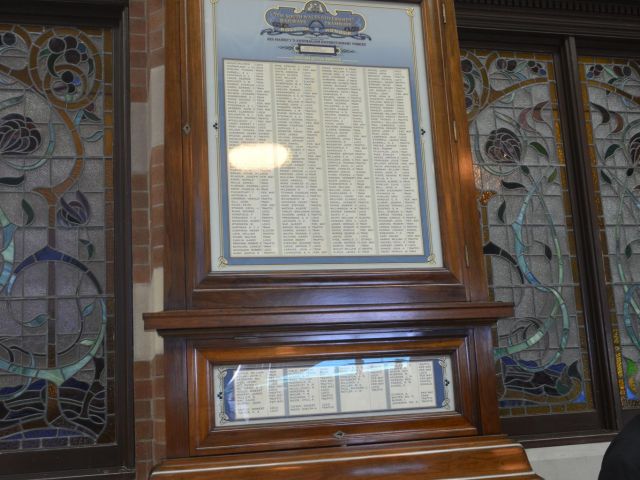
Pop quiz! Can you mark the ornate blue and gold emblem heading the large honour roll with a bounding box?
[260,0,371,40]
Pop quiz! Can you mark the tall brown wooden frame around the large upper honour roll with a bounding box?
[165,0,486,308]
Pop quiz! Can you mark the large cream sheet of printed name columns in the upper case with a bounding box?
[224,60,425,258]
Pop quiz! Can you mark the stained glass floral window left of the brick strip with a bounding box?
[0,24,114,453]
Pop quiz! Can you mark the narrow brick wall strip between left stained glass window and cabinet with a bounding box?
[129,0,165,479]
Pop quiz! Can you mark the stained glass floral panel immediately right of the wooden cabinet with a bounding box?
[461,50,592,417]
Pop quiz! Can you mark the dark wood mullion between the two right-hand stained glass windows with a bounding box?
[558,36,621,430]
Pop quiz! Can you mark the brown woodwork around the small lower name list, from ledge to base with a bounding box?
[145,302,539,479]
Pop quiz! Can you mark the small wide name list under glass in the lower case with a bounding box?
[218,359,441,422]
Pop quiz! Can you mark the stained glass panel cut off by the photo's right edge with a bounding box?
[579,57,640,408]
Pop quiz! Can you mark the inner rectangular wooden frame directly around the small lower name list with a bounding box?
[188,332,478,456]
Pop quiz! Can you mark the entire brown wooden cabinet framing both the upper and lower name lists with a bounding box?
[145,0,538,479]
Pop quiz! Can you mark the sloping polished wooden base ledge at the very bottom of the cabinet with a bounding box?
[150,435,540,480]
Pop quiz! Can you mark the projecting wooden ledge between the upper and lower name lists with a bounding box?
[144,302,513,333]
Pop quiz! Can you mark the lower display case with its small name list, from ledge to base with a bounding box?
[145,303,538,479]
